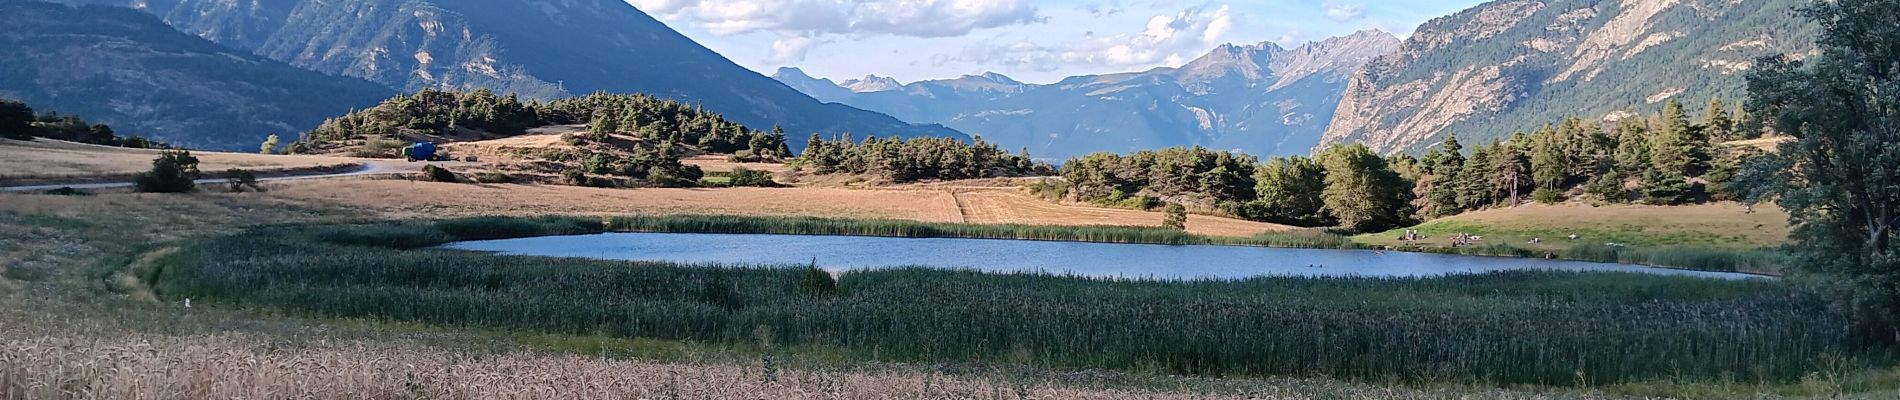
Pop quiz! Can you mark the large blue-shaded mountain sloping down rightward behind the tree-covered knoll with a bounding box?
[67,0,963,144]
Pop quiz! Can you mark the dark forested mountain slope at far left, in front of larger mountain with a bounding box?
[0,0,395,150]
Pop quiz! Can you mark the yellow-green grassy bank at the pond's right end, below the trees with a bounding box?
[1355,203,1788,250]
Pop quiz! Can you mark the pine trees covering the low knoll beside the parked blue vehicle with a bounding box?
[291,89,790,159]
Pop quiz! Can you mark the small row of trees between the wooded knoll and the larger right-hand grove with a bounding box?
[792,135,1055,182]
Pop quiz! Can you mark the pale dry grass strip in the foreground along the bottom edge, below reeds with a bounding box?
[0,326,1641,400]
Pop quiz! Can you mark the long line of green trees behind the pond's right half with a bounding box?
[1045,99,1761,231]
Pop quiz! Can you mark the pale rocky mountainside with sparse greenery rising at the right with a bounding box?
[1321,0,1815,154]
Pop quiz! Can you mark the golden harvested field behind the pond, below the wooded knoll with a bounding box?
[260,180,1294,237]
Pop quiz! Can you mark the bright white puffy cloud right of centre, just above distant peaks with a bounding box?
[963,6,1233,70]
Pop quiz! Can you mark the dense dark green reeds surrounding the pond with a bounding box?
[156,216,1887,385]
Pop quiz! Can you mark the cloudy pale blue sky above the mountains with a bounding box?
[627,0,1480,83]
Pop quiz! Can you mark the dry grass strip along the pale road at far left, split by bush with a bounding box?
[0,138,363,182]
